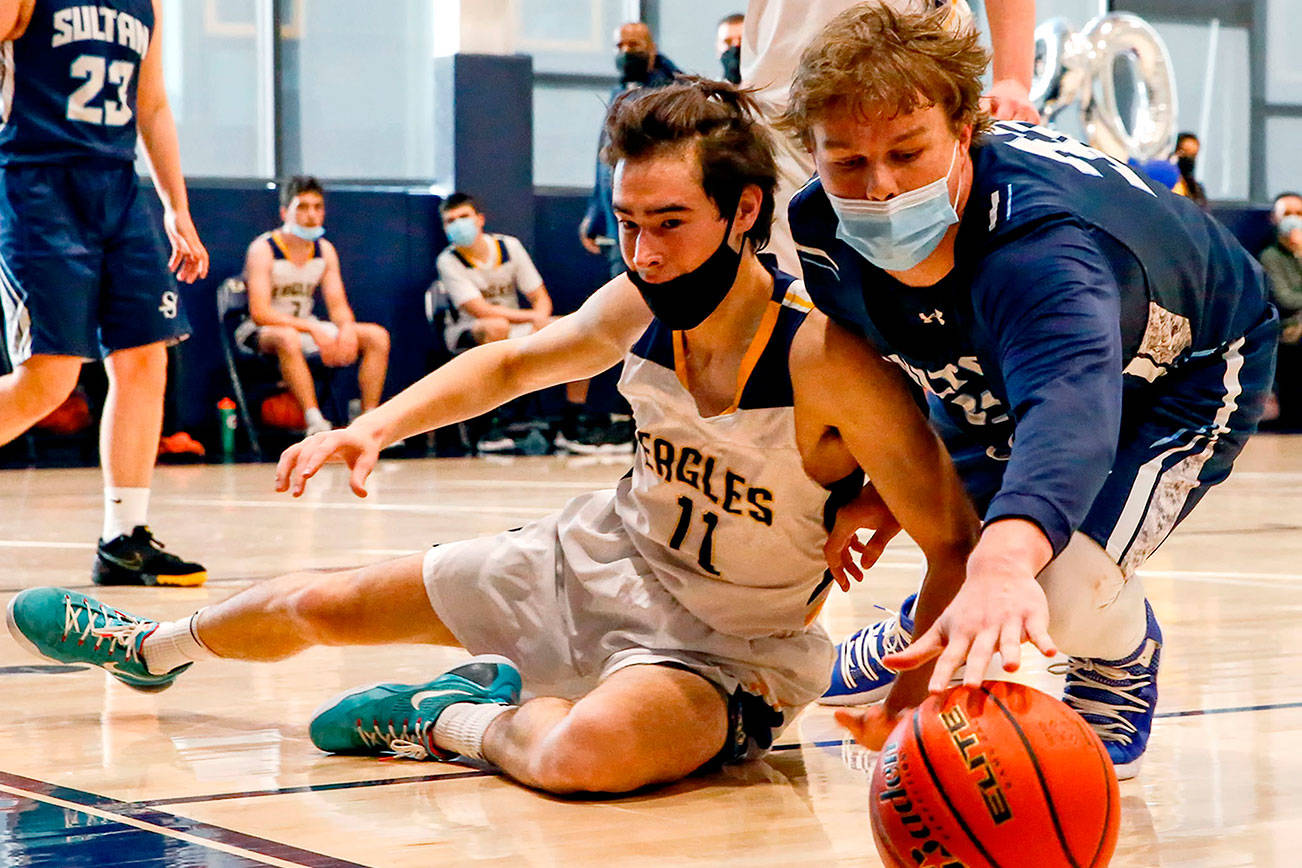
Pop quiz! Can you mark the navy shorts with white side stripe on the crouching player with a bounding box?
[947,310,1279,578]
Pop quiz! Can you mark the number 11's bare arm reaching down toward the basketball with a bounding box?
[792,312,980,728]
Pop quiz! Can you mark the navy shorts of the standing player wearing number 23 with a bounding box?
[0,161,190,366]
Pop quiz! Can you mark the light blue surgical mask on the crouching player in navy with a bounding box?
[827,142,958,271]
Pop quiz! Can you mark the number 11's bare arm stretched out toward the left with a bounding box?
[276,276,651,497]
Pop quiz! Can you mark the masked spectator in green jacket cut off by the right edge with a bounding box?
[1259,193,1302,429]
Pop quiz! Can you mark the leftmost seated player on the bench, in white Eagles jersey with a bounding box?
[234,176,389,436]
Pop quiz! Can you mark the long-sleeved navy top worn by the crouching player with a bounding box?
[790,124,1269,550]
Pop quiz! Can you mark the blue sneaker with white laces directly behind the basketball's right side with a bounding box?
[1051,600,1161,781]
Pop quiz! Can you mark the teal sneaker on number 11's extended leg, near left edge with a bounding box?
[5,588,190,694]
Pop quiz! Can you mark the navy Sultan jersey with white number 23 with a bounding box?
[0,0,154,165]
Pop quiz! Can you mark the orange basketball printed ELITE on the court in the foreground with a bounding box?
[871,681,1121,868]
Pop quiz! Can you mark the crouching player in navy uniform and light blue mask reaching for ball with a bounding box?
[784,4,1277,777]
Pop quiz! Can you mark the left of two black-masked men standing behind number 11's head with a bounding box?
[578,21,678,277]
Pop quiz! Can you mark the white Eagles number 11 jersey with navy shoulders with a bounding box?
[591,265,861,638]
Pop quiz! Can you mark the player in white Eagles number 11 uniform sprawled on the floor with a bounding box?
[10,79,977,793]
